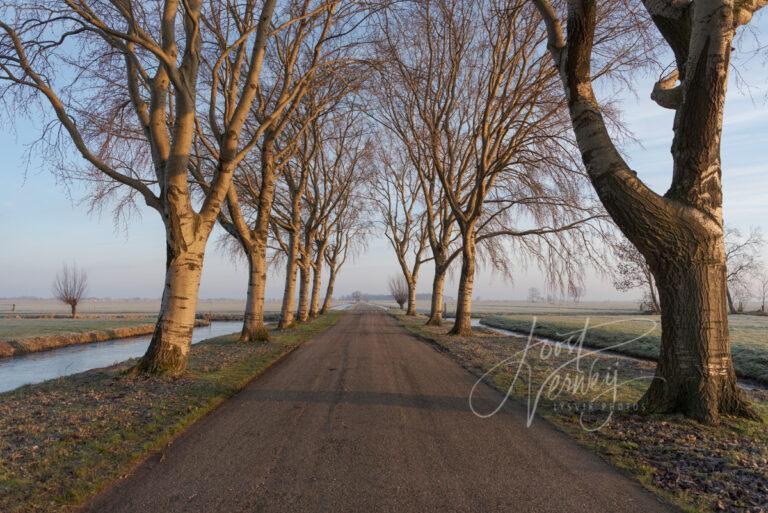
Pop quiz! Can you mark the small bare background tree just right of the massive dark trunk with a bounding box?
[725,226,765,314]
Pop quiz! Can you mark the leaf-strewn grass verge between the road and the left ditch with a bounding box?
[0,312,342,513]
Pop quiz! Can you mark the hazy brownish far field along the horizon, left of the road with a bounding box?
[0,298,280,316]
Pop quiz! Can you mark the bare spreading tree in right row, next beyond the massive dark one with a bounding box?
[376,0,599,335]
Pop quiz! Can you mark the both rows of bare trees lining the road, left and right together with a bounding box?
[0,0,766,422]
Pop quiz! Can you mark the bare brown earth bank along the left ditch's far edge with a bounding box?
[0,319,211,358]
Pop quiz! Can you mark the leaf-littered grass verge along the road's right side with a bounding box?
[394,314,768,513]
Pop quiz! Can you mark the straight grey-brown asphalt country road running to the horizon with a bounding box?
[85,306,677,513]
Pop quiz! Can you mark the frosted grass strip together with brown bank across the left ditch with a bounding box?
[0,318,210,358]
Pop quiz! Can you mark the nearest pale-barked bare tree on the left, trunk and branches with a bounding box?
[0,0,276,375]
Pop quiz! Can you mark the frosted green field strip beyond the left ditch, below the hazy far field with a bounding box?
[0,316,155,340]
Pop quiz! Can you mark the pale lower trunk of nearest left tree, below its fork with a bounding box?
[134,245,203,376]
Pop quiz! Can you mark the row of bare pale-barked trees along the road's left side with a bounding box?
[0,0,370,374]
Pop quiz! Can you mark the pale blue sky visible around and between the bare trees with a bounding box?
[0,14,768,300]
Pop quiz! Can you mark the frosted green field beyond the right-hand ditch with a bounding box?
[481,314,768,384]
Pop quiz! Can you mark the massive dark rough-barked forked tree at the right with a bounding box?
[534,0,766,423]
